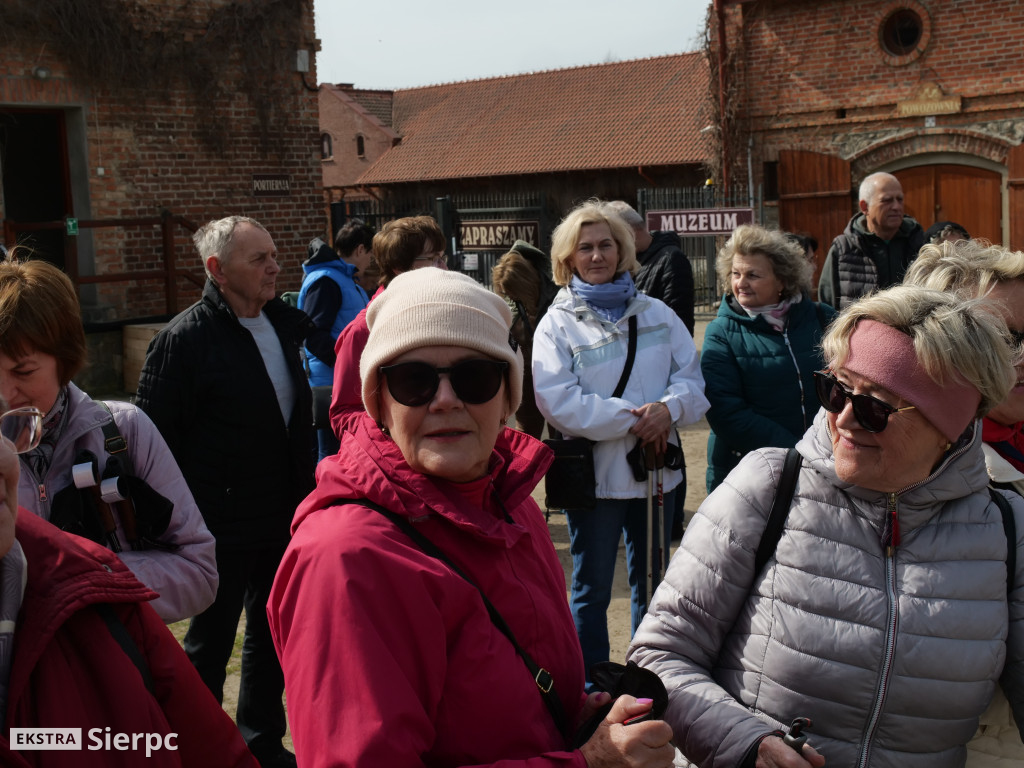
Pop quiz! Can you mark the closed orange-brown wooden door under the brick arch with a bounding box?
[893,165,1002,244]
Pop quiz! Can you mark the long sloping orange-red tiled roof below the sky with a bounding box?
[358,52,708,184]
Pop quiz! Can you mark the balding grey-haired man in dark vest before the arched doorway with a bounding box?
[818,173,925,309]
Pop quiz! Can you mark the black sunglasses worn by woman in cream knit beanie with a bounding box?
[380,359,509,408]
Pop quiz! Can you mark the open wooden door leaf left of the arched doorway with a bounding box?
[778,150,857,286]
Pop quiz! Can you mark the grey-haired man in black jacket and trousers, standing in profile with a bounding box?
[137,216,315,768]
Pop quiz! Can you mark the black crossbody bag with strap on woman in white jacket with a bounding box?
[544,314,637,509]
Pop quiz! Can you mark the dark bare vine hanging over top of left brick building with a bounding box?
[0,0,312,153]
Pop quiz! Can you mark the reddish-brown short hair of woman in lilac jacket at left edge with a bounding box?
[0,248,86,386]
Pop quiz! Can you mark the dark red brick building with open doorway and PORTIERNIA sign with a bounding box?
[0,0,325,331]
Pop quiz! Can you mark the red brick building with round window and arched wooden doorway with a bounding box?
[709,0,1024,276]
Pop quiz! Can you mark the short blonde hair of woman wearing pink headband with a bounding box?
[821,285,1017,418]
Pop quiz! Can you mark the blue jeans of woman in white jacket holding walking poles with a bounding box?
[565,489,676,690]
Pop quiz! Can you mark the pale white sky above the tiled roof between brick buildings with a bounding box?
[314,0,711,89]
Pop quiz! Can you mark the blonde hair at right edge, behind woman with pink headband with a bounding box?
[903,240,1024,299]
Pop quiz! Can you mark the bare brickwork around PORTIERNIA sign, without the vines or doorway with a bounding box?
[0,0,326,319]
